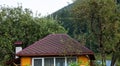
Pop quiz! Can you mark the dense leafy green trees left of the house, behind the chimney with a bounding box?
[0,6,67,65]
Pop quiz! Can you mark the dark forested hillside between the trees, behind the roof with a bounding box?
[48,3,98,52]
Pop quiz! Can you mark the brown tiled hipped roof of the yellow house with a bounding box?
[16,34,94,56]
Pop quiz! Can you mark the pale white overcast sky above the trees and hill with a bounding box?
[0,0,72,16]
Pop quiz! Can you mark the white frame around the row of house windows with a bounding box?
[32,56,77,66]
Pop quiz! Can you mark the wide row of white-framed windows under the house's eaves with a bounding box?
[32,57,76,66]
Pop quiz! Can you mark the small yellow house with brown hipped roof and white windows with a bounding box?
[16,34,95,66]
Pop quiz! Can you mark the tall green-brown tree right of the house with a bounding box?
[72,0,120,66]
